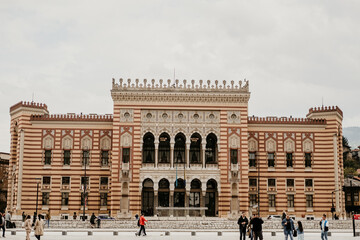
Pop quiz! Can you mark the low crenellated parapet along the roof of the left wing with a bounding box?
[30,114,113,122]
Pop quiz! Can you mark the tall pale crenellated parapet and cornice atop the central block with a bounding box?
[111,78,250,104]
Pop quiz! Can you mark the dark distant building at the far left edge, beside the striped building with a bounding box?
[0,152,10,212]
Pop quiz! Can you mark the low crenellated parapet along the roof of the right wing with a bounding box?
[248,116,326,125]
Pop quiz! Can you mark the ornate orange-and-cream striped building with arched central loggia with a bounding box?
[8,79,345,218]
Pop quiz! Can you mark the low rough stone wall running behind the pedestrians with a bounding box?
[11,219,360,230]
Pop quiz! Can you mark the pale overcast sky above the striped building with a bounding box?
[0,0,360,152]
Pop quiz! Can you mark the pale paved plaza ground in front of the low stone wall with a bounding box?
[2,231,360,240]
